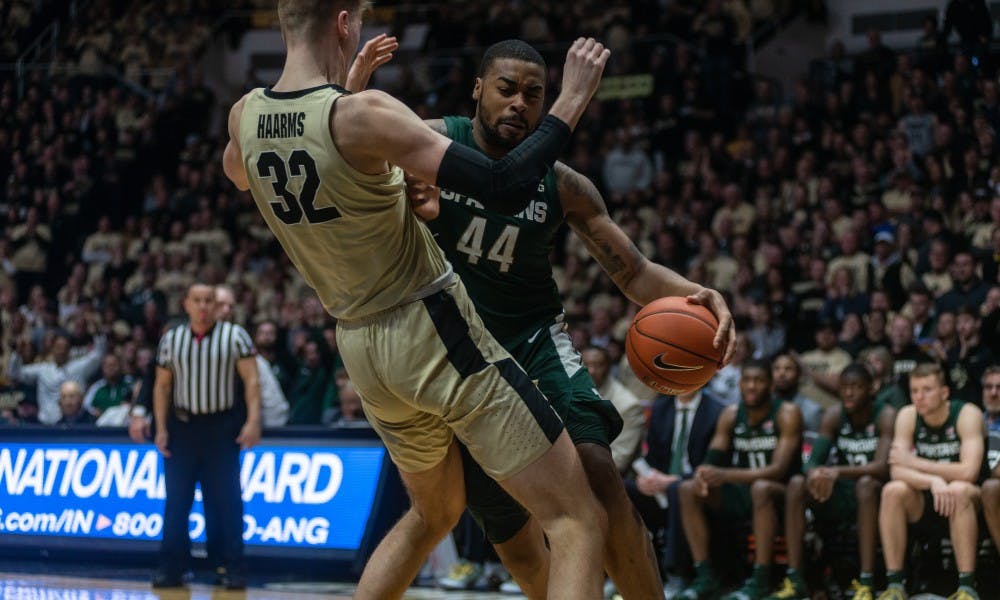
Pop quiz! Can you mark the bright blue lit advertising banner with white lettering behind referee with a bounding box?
[0,440,385,551]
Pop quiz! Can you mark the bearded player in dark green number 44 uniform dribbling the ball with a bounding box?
[402,40,735,599]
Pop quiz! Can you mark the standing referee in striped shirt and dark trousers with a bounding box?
[153,283,260,589]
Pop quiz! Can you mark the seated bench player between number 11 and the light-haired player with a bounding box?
[770,363,896,600]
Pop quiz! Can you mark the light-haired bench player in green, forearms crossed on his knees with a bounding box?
[878,363,986,600]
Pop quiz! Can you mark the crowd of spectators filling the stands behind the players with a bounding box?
[0,0,1000,436]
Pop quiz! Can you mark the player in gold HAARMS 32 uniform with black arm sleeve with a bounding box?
[224,0,610,600]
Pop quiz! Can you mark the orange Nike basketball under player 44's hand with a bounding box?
[625,297,722,396]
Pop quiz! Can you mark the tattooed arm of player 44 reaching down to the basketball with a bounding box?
[555,163,736,365]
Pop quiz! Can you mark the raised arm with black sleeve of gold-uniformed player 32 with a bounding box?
[331,39,609,214]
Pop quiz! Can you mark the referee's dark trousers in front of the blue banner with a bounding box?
[160,410,244,575]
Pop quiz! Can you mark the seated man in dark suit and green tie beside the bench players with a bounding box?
[625,390,725,589]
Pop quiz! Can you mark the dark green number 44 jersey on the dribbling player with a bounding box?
[428,117,563,346]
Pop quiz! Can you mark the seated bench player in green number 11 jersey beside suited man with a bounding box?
[676,359,802,600]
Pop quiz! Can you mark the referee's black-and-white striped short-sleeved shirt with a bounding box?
[156,322,254,415]
